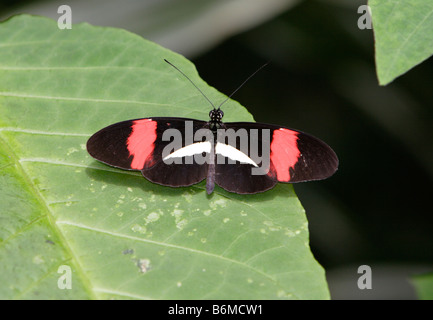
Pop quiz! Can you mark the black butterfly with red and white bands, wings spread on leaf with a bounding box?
[87,60,338,194]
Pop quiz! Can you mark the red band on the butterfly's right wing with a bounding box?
[271,128,301,182]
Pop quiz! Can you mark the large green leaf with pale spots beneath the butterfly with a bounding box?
[0,16,329,299]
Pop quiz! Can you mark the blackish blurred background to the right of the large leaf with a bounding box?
[0,0,433,299]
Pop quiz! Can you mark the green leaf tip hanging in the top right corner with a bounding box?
[369,0,433,85]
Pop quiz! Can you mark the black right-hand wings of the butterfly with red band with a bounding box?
[215,122,338,194]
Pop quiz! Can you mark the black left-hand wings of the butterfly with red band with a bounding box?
[87,117,207,187]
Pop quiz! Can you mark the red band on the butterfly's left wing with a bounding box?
[127,119,157,170]
